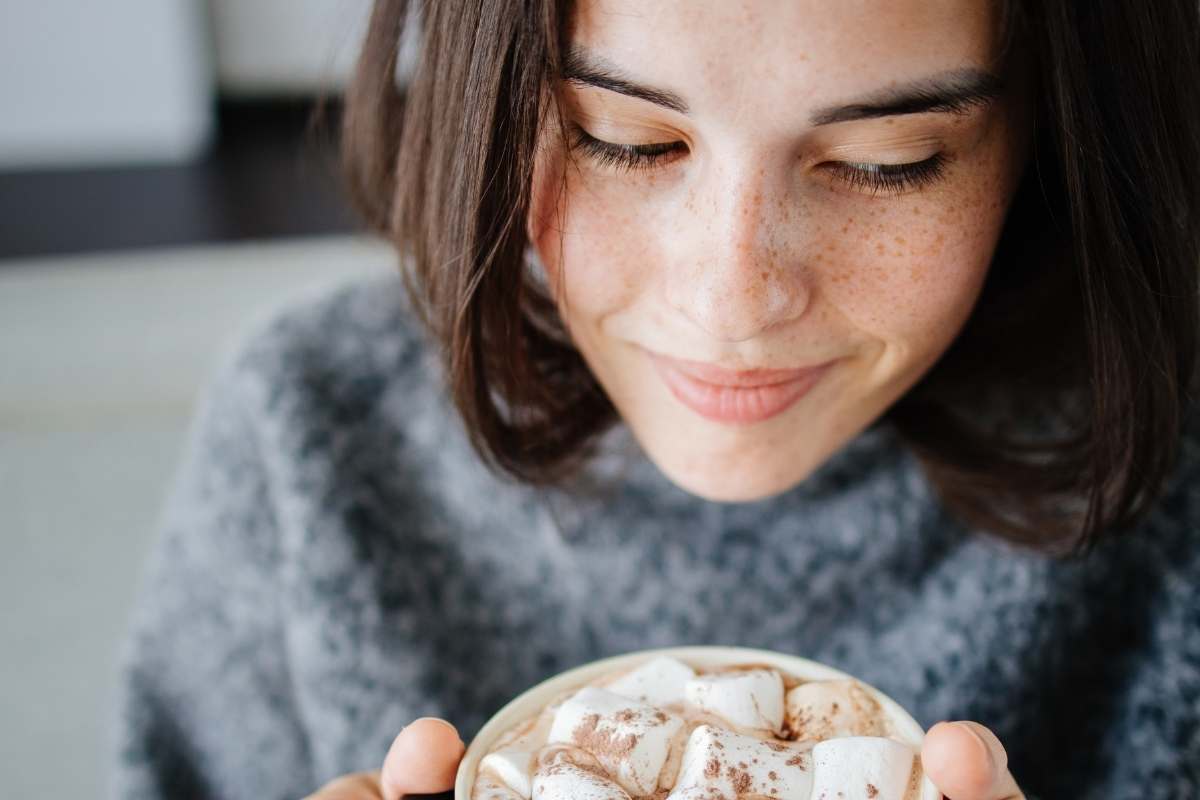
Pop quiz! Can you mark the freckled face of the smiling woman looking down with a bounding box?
[529,0,1028,501]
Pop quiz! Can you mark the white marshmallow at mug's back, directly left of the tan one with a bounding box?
[684,669,784,735]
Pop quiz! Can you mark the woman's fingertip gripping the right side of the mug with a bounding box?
[920,722,1026,800]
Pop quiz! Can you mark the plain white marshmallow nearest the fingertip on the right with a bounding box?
[812,736,917,800]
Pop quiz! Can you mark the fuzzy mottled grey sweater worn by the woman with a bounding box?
[112,271,1200,800]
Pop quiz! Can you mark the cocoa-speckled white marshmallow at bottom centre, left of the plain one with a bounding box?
[668,724,812,800]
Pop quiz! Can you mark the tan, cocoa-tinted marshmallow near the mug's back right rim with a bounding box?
[786,680,889,741]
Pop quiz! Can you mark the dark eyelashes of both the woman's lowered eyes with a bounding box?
[571,126,946,194]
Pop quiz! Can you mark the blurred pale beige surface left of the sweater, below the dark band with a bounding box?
[0,236,392,798]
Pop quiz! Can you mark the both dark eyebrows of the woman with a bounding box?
[563,46,1004,126]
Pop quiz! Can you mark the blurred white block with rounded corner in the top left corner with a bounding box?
[0,0,213,169]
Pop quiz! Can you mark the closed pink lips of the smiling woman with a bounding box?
[647,351,834,425]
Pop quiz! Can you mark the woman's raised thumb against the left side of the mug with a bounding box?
[380,717,467,800]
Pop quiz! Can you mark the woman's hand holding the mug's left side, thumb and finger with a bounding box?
[305,717,467,800]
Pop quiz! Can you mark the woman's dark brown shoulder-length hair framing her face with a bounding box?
[343,0,1200,552]
